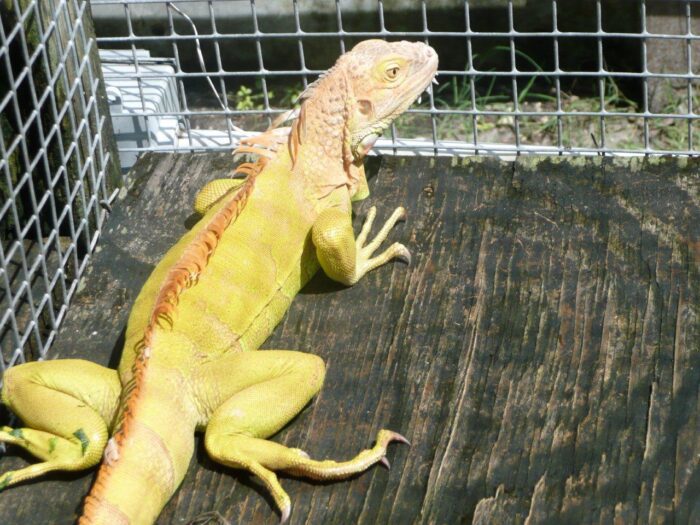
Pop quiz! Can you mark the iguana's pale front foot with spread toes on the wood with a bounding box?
[354,206,411,282]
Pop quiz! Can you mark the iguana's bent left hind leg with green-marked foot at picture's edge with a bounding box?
[0,359,121,489]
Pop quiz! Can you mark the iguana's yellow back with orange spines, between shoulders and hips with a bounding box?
[120,147,318,370]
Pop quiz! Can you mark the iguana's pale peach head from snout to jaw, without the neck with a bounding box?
[344,40,438,160]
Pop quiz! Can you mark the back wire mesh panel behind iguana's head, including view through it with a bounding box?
[92,0,700,158]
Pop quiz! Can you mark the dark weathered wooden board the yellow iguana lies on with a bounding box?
[0,150,700,524]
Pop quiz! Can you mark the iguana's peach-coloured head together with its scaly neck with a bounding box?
[290,40,438,168]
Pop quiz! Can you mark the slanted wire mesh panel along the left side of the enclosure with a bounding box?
[0,0,115,372]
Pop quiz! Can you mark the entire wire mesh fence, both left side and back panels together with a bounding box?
[0,0,700,371]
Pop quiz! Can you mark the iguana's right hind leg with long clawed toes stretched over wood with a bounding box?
[197,350,405,522]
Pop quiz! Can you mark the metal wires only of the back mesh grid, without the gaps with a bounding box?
[92,0,700,155]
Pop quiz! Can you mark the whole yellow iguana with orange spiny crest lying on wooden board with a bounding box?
[0,40,438,525]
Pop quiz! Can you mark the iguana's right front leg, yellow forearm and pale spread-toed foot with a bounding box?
[311,206,411,286]
